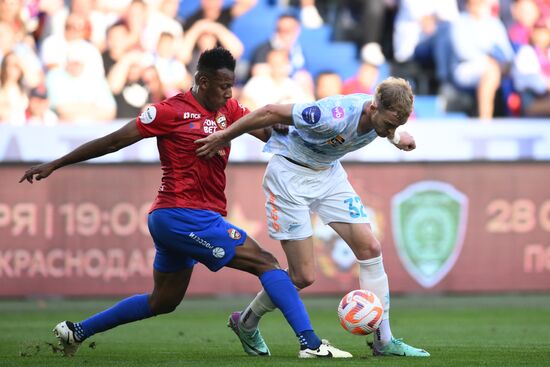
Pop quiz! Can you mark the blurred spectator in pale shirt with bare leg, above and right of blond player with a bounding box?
[451,0,514,120]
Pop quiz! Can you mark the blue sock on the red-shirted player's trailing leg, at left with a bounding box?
[74,294,153,341]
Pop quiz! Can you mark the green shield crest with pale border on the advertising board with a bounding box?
[392,181,468,288]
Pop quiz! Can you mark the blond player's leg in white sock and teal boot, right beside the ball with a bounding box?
[330,222,430,357]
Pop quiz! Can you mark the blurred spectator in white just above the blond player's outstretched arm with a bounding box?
[240,49,313,110]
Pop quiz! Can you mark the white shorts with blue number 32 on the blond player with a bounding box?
[263,155,369,240]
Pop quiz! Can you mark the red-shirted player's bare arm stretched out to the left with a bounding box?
[19,120,143,184]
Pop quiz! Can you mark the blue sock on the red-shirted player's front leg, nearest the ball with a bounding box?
[260,269,321,349]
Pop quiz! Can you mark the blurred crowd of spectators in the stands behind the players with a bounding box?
[0,0,550,125]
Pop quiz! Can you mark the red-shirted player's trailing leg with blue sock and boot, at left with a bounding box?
[53,267,193,356]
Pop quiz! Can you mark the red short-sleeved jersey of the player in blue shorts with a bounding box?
[136,91,250,216]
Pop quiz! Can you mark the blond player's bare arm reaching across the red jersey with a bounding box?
[195,104,293,158]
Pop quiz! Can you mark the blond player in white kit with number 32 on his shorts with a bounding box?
[196,78,430,357]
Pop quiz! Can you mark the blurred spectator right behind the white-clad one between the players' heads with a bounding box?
[250,13,306,76]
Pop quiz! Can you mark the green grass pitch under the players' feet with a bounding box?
[0,295,550,367]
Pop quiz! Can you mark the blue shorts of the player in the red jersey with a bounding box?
[148,208,246,273]
